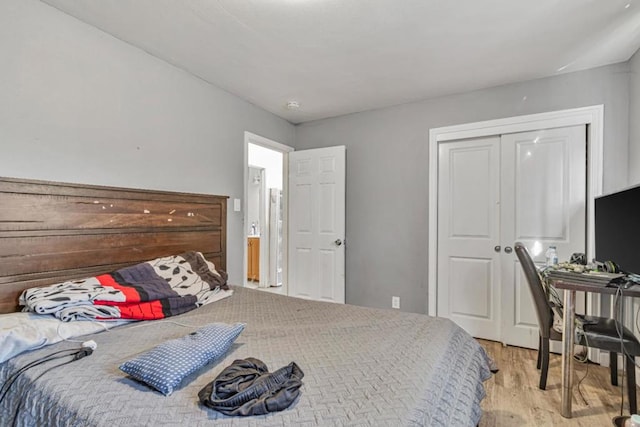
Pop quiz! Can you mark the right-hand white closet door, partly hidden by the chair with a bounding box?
[501,126,587,348]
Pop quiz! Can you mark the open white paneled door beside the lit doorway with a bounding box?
[288,146,346,303]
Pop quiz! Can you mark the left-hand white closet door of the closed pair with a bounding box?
[438,136,501,341]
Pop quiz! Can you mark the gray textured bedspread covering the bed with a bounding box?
[0,287,491,426]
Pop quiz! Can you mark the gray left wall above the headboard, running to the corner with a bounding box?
[0,0,294,283]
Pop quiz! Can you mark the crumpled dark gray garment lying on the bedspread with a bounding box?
[198,357,304,416]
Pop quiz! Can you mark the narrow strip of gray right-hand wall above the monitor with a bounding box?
[629,50,640,185]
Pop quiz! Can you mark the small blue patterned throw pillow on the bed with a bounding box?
[120,323,244,396]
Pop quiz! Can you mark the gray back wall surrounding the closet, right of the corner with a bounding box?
[295,63,629,313]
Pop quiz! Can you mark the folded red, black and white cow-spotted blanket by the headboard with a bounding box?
[20,252,232,321]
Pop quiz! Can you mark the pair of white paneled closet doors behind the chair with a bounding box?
[437,126,586,348]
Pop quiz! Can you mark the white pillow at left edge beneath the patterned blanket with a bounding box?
[0,312,129,363]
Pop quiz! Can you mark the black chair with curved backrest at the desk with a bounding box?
[515,242,640,414]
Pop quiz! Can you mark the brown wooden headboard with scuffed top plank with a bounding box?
[0,178,227,313]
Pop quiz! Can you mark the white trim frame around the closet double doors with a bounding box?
[427,104,604,316]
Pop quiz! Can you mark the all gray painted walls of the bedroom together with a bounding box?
[0,0,640,312]
